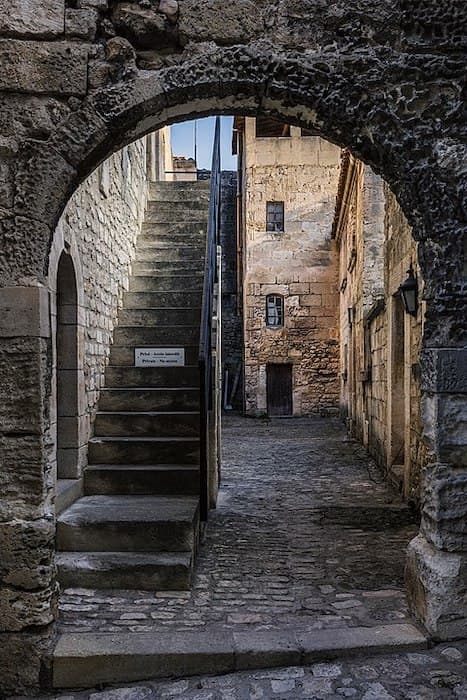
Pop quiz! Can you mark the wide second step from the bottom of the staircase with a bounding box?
[57,496,199,552]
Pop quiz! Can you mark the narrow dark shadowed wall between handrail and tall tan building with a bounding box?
[220,171,243,410]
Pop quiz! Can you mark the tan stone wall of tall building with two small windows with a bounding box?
[244,118,339,415]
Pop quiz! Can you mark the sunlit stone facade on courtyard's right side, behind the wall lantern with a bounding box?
[334,151,426,504]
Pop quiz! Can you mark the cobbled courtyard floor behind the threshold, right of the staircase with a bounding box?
[60,416,417,636]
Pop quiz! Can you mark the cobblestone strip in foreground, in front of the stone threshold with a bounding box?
[22,642,467,700]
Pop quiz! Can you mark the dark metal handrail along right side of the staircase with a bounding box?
[198,117,221,522]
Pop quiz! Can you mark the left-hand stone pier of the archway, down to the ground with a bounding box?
[0,286,57,696]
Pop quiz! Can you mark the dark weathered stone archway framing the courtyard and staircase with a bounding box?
[0,5,467,690]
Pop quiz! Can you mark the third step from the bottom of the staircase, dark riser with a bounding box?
[84,464,199,496]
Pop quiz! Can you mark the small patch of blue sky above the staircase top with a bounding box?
[172,117,237,170]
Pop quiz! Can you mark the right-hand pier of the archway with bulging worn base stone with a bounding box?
[406,347,467,639]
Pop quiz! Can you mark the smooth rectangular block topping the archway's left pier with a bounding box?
[0,287,50,338]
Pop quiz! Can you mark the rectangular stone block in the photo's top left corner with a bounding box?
[0,0,65,38]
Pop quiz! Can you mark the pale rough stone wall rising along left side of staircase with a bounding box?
[49,139,147,476]
